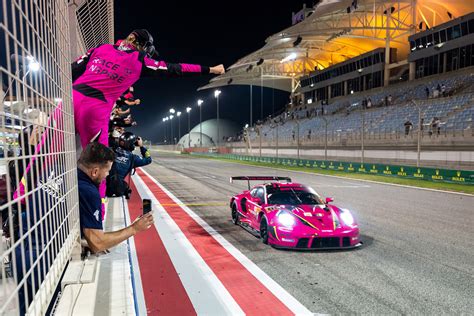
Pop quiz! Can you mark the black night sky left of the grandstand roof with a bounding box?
[115,0,312,142]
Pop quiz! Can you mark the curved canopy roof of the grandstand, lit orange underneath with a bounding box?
[199,0,474,92]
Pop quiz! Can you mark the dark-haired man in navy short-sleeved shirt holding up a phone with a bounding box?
[77,142,153,253]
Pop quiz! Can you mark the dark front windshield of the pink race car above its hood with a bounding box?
[267,188,324,205]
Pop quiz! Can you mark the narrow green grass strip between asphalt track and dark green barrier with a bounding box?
[191,156,474,195]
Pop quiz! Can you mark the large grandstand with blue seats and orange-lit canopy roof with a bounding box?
[201,0,474,168]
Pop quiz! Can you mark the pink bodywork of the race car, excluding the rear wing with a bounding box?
[230,182,361,249]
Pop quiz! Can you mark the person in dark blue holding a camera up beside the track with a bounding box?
[106,132,152,199]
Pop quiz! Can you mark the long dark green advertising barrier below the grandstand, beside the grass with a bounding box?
[191,153,474,184]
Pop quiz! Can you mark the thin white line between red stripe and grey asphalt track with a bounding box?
[141,168,314,315]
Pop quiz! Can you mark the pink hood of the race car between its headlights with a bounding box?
[276,205,343,232]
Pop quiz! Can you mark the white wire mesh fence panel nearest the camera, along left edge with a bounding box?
[0,0,80,315]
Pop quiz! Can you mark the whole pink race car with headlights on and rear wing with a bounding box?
[230,176,362,249]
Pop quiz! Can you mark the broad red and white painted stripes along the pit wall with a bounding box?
[128,169,313,316]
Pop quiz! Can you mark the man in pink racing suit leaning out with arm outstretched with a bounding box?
[72,29,224,212]
